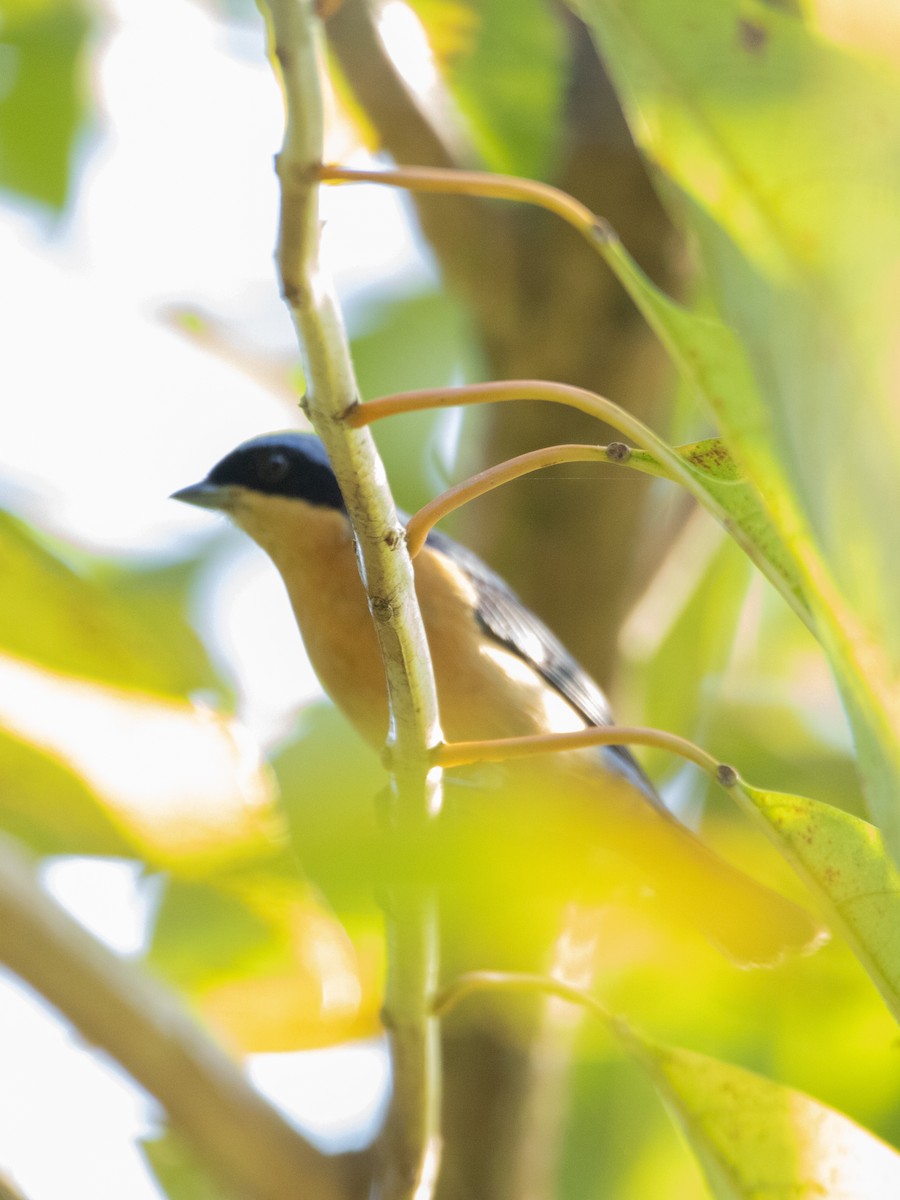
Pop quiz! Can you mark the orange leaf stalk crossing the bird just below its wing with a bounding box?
[434,725,732,786]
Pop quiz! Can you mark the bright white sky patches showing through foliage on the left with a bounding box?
[0,0,426,1200]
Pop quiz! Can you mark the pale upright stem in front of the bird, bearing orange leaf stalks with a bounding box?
[260,0,440,1200]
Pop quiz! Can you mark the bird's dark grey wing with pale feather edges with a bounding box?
[427,530,661,804]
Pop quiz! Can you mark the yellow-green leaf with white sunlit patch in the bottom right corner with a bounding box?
[619,1027,900,1200]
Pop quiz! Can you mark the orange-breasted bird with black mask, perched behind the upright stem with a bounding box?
[173,431,827,967]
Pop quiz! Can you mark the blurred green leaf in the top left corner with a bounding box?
[0,0,90,209]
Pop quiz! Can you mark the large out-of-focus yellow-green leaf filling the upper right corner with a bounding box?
[582,0,900,853]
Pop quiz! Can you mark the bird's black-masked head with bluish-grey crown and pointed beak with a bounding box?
[175,432,346,511]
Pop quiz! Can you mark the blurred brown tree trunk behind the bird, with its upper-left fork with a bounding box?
[329,0,683,1200]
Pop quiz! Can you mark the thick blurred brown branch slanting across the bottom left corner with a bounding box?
[0,838,347,1200]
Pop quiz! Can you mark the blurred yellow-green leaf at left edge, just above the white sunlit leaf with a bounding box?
[0,514,224,697]
